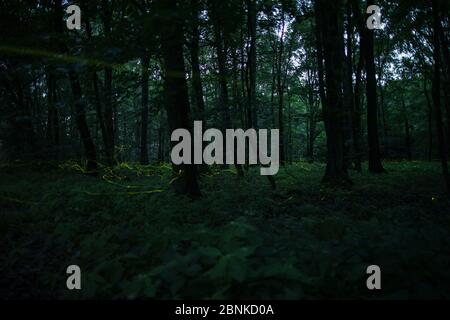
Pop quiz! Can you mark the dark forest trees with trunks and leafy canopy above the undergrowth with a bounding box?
[0,0,450,190]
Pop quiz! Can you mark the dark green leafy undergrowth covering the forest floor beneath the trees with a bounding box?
[0,162,450,299]
